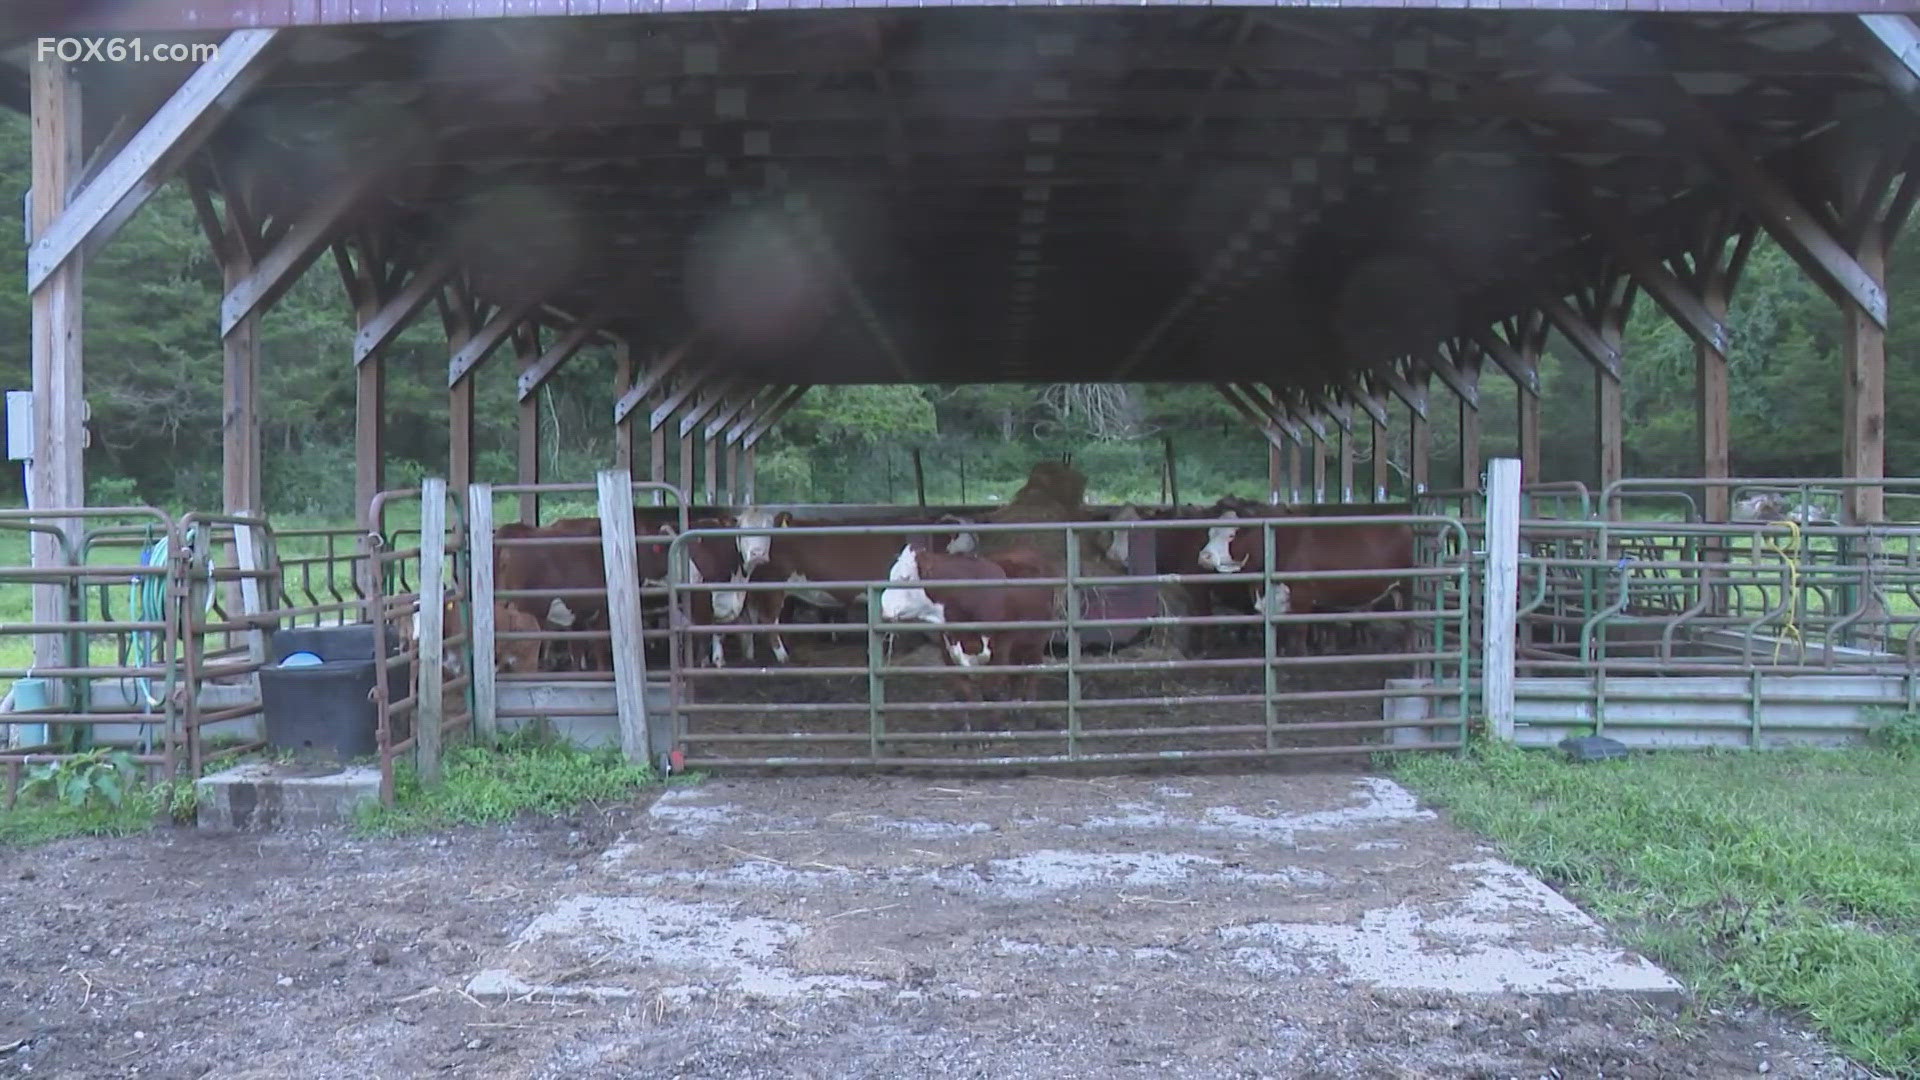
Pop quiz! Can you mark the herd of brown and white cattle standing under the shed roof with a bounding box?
[462,498,1413,688]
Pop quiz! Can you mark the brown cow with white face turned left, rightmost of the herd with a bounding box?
[1200,511,1413,653]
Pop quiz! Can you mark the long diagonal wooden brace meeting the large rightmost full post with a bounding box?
[1665,85,1887,328]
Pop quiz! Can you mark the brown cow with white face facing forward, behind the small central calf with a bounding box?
[737,509,977,663]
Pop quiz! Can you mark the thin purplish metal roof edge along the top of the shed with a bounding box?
[6,0,1920,35]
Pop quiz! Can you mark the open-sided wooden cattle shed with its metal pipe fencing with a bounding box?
[0,0,1920,796]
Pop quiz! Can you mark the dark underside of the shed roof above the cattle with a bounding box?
[3,9,1912,395]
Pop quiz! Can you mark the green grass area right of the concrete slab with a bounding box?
[1398,744,1920,1076]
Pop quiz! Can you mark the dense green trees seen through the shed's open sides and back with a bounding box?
[0,115,1920,517]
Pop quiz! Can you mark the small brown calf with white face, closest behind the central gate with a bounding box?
[879,544,1054,701]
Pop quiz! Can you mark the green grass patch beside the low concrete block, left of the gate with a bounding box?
[355,734,657,836]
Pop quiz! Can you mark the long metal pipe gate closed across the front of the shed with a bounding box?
[668,515,1471,767]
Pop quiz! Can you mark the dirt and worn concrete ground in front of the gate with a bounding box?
[0,773,1864,1080]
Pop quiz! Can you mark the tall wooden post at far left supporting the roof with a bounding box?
[27,58,86,701]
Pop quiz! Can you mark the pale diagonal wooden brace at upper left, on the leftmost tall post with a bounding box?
[27,29,282,292]
